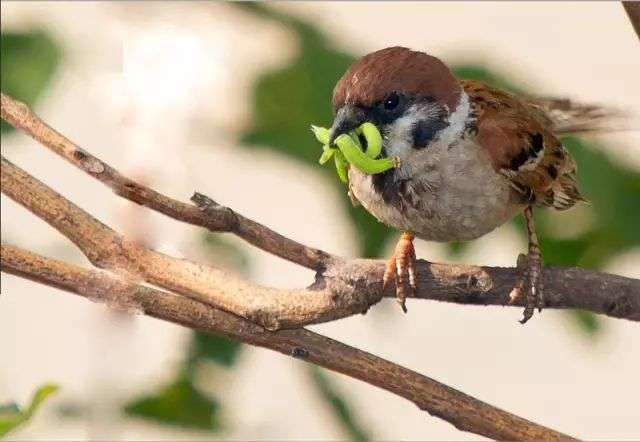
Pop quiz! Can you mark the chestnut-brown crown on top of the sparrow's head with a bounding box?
[332,46,461,111]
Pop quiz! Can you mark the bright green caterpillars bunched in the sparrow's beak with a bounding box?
[311,122,397,183]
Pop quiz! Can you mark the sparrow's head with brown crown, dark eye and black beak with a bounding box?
[330,47,462,164]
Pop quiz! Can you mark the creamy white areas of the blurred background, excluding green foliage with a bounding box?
[0,2,640,440]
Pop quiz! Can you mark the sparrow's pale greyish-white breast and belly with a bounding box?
[349,139,523,241]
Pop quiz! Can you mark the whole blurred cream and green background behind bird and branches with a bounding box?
[0,2,640,440]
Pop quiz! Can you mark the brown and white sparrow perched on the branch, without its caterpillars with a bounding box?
[329,46,608,323]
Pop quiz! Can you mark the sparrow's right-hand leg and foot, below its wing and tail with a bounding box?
[509,206,544,324]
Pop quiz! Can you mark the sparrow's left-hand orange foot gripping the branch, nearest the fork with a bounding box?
[382,232,417,313]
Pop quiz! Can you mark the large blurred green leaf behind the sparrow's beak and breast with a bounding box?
[236,3,393,257]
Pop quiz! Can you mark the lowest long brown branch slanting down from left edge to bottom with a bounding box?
[0,244,570,440]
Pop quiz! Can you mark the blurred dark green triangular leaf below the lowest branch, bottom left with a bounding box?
[125,378,220,431]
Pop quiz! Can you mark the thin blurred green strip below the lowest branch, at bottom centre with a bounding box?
[308,365,371,441]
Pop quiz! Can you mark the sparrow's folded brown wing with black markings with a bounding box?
[461,81,584,210]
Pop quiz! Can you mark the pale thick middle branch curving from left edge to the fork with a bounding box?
[2,157,382,329]
